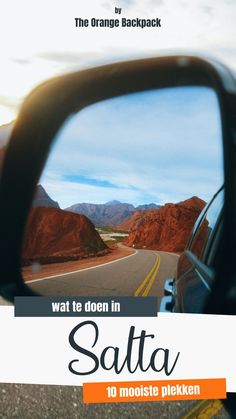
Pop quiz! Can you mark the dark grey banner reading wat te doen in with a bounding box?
[15,297,157,317]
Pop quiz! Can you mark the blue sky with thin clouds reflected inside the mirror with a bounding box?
[40,87,223,208]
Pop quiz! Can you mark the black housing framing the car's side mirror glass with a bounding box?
[0,56,236,313]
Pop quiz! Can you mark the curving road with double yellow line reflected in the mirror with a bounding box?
[27,250,178,310]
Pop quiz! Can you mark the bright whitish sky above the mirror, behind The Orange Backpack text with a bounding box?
[0,0,236,125]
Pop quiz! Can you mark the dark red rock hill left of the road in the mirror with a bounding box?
[22,208,108,265]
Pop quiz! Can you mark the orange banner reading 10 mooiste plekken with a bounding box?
[83,378,226,403]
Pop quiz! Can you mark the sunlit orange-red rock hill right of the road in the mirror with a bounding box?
[122,196,205,253]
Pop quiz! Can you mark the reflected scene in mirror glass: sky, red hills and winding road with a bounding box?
[22,86,223,308]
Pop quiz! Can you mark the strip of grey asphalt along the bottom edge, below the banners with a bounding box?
[0,384,230,419]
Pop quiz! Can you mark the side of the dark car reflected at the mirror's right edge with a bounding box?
[160,187,224,313]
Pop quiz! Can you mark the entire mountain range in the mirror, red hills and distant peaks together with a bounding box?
[29,185,205,254]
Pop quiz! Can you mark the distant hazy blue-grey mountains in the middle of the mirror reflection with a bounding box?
[66,201,158,226]
